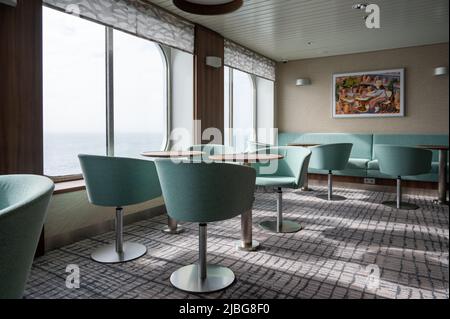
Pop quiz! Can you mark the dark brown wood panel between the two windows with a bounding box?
[194,25,224,143]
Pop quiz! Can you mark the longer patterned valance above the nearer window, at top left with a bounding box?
[44,0,194,53]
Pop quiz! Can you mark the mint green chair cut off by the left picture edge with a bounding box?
[0,175,54,299]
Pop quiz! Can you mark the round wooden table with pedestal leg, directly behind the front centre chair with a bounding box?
[209,154,283,251]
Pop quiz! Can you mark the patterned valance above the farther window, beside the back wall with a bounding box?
[224,39,276,81]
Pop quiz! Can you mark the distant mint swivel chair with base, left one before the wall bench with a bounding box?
[309,143,353,201]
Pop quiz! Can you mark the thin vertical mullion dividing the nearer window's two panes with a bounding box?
[106,27,114,156]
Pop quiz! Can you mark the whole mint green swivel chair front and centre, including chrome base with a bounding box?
[155,159,256,293]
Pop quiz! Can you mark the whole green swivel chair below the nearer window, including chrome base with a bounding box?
[78,155,162,263]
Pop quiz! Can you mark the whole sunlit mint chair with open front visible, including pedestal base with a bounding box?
[253,147,311,233]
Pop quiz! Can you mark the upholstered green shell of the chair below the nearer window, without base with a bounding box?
[78,155,162,207]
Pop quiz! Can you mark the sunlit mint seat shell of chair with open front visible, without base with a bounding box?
[252,146,311,188]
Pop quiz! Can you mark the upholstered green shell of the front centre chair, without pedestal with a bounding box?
[155,159,256,223]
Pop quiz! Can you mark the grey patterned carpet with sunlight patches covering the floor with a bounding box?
[25,188,449,298]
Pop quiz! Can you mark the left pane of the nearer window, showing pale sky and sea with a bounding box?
[43,7,106,176]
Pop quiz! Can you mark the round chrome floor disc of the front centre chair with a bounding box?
[170,264,235,293]
